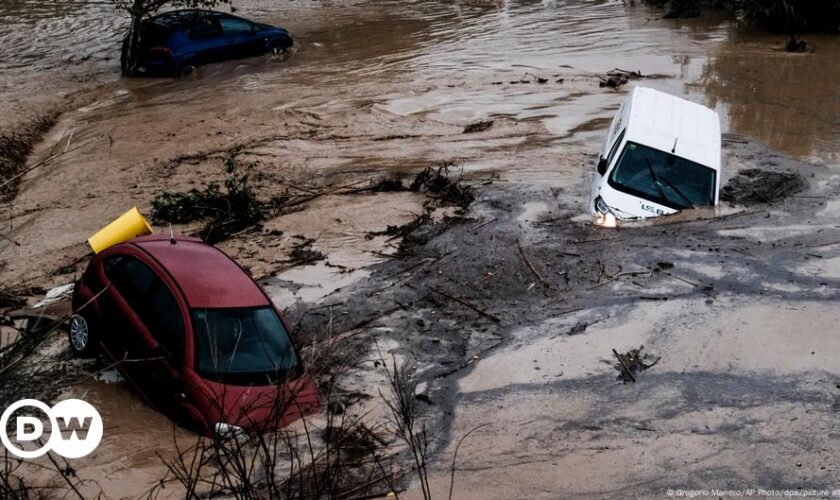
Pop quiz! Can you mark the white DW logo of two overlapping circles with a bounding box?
[0,399,102,458]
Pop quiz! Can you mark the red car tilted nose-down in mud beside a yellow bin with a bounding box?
[69,235,319,434]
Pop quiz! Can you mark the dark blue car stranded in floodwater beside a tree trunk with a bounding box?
[121,10,294,75]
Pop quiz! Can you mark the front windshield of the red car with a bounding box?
[192,307,300,385]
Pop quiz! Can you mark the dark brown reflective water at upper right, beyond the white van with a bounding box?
[700,30,840,163]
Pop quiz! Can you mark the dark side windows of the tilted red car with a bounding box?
[105,256,185,365]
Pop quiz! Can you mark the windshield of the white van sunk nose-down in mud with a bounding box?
[609,142,717,210]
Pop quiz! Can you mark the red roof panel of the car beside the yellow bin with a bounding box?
[130,235,270,308]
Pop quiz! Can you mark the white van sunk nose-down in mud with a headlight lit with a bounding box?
[590,87,721,226]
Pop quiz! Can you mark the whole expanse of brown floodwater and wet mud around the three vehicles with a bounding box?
[0,0,840,498]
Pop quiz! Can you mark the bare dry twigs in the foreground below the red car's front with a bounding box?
[150,354,442,500]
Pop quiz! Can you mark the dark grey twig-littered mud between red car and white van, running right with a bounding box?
[287,136,840,476]
